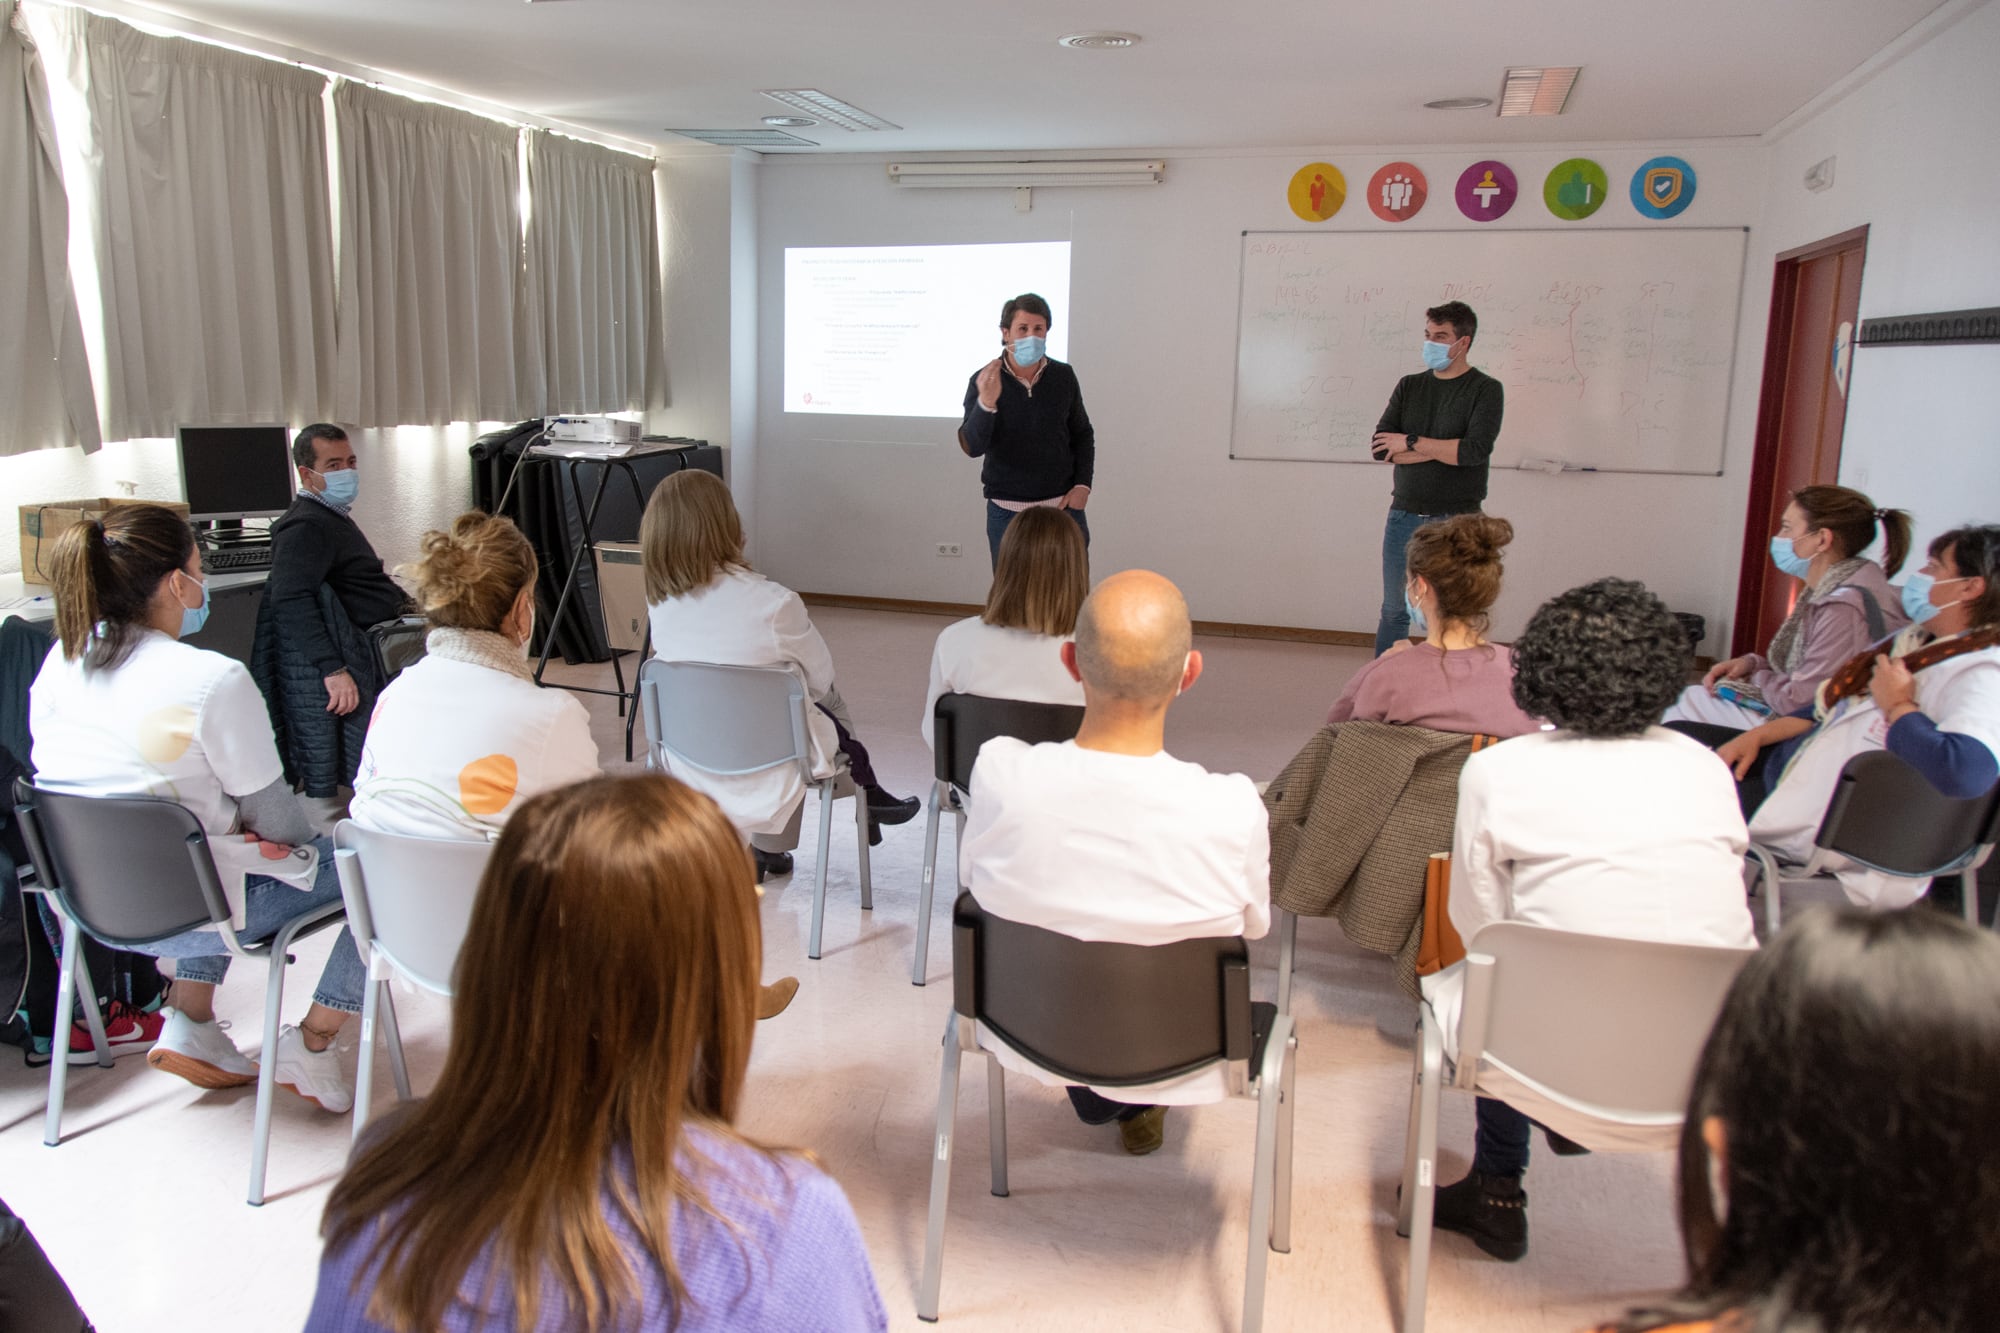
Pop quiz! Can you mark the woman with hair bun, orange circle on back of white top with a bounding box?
[350,512,598,841]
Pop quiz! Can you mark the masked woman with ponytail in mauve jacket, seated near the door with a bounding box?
[1664,486,1910,731]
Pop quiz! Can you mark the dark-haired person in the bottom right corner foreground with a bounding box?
[1606,907,2000,1333]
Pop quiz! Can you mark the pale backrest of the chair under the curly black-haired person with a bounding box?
[1458,921,1754,1115]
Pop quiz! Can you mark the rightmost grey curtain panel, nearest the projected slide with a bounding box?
[522,130,666,412]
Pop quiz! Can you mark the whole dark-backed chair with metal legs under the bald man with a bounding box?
[916,893,1298,1333]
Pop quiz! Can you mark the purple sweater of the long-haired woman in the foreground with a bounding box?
[306,1127,888,1333]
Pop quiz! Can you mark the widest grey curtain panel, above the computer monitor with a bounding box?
[60,10,334,440]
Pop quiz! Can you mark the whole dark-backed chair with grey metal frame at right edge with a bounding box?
[1750,751,2000,935]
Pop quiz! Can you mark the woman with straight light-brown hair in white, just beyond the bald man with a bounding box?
[922,506,1090,749]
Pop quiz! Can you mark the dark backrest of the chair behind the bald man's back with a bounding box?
[952,893,1252,1087]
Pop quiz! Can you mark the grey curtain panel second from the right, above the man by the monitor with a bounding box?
[334,80,524,426]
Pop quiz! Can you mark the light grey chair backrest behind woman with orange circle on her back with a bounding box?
[334,819,492,995]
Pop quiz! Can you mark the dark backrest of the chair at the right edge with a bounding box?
[1812,751,2000,877]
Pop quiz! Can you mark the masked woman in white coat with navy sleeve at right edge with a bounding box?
[1718,524,2000,909]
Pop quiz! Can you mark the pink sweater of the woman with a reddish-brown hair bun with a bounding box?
[1326,642,1542,739]
